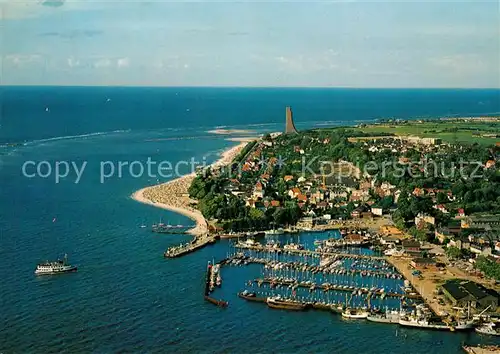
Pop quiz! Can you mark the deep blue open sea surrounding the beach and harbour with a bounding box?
[0,87,500,354]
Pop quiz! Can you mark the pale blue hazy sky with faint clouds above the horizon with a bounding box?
[0,0,500,88]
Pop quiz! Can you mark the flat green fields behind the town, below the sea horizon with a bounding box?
[354,121,500,145]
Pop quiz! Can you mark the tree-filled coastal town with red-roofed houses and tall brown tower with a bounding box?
[189,109,500,334]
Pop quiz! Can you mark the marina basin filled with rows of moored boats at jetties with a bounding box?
[194,231,500,333]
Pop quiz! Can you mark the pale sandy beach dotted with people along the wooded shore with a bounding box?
[131,142,247,237]
